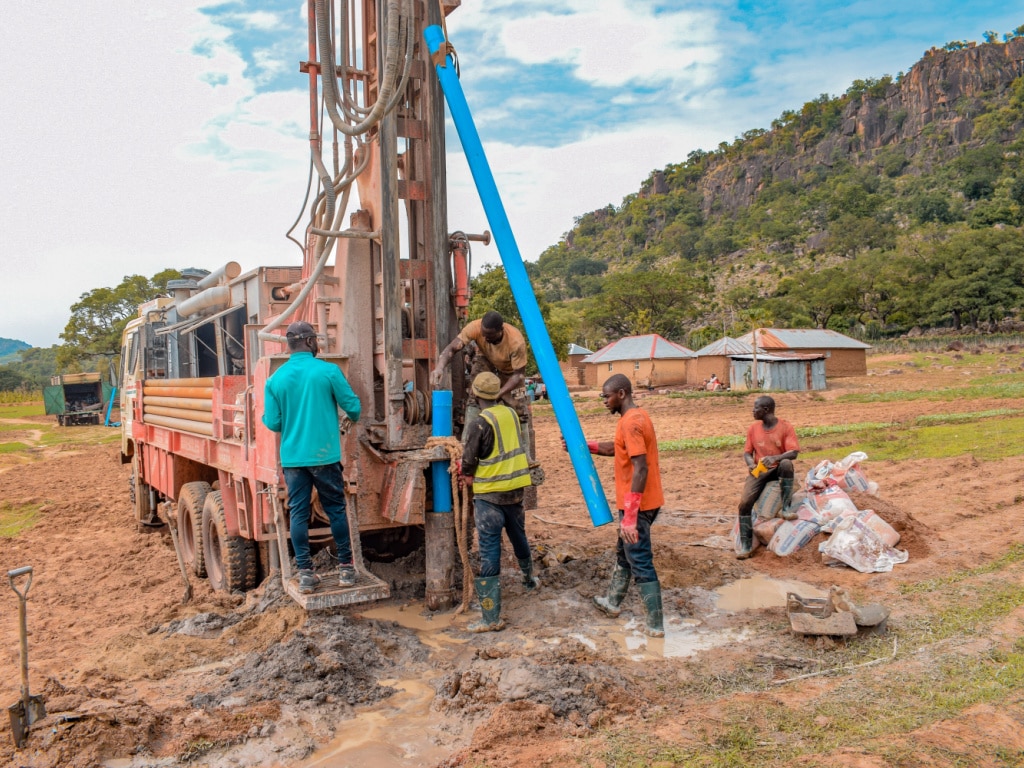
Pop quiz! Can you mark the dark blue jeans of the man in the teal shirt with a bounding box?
[284,463,352,569]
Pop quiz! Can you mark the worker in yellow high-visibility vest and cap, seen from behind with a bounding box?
[461,372,540,632]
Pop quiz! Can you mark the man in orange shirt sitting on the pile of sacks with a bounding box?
[736,395,800,560]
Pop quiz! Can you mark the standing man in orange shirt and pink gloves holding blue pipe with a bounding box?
[587,374,665,637]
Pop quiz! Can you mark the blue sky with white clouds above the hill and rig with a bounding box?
[0,0,1024,346]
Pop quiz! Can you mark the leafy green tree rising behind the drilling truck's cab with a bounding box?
[57,269,181,371]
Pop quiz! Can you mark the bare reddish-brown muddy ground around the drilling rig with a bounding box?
[0,350,1024,768]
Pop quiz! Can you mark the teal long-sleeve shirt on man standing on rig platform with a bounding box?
[263,352,362,467]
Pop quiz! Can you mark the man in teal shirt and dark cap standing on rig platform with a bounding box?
[263,322,361,594]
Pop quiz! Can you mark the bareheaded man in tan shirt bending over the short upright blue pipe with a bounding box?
[430,311,532,456]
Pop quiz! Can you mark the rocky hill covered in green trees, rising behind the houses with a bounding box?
[530,26,1024,348]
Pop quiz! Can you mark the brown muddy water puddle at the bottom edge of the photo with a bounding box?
[299,677,452,768]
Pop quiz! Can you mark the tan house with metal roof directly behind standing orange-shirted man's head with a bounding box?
[583,334,696,387]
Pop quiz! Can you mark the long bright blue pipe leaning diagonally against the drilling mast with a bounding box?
[423,26,611,525]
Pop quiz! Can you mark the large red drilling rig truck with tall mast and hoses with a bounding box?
[120,0,520,609]
